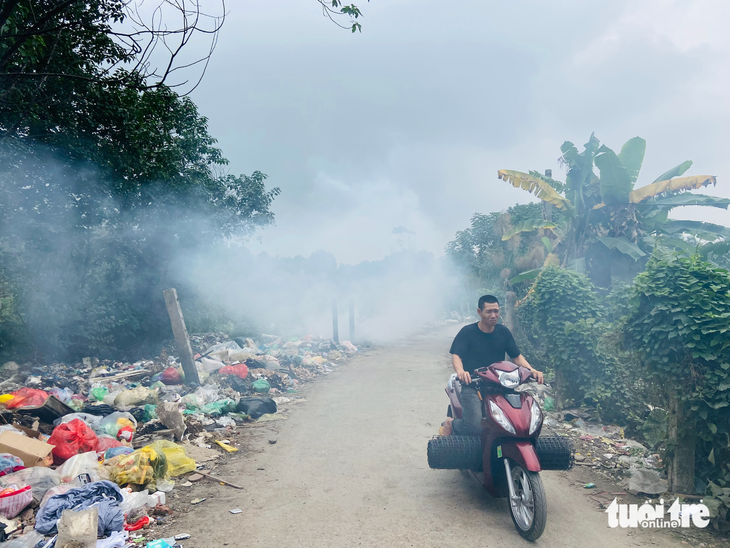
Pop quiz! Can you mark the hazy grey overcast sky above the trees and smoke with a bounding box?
[192,0,730,263]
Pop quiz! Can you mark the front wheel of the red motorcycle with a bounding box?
[509,464,547,541]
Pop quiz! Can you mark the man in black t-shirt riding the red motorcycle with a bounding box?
[439,295,543,436]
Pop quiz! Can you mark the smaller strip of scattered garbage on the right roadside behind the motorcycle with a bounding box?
[522,384,669,496]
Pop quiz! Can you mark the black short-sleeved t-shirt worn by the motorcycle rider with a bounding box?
[449,323,520,374]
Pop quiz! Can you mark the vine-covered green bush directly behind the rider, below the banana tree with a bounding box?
[516,268,657,430]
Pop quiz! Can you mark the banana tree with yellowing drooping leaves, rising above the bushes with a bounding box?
[498,135,730,287]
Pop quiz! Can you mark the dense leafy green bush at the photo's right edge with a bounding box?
[626,251,730,521]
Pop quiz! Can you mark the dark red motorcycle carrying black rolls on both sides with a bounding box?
[427,362,574,541]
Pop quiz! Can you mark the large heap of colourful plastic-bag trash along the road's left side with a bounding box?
[0,334,358,548]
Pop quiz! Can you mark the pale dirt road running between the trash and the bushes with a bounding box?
[171,327,686,548]
